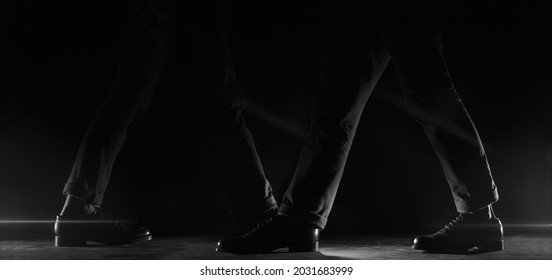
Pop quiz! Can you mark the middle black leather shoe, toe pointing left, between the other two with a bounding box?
[217,215,320,254]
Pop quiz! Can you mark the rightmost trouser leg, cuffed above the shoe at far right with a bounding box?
[377,0,498,212]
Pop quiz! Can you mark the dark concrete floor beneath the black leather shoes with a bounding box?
[0,233,552,260]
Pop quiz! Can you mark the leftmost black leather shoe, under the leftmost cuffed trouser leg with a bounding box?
[54,209,152,247]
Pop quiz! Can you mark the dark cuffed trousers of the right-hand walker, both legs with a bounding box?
[280,0,498,228]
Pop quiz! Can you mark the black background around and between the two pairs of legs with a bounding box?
[0,0,552,235]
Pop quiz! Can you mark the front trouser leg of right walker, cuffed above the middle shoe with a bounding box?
[280,1,390,228]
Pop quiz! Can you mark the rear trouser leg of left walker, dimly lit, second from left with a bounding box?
[113,0,277,221]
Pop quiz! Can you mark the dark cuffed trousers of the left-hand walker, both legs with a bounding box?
[64,0,277,223]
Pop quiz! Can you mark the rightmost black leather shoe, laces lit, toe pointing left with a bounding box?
[412,213,504,253]
